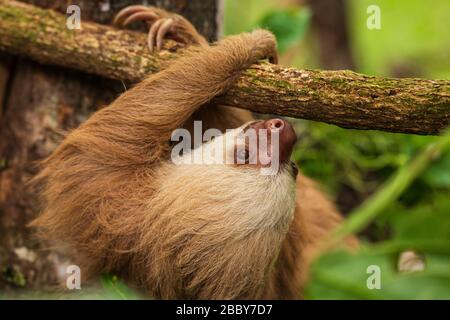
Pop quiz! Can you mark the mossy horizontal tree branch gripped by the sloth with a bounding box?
[0,0,450,134]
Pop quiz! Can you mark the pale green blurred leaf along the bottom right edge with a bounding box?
[306,247,450,299]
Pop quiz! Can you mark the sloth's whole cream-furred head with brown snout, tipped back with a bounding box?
[158,119,297,235]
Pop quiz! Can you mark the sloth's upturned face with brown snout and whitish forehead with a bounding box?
[177,119,297,177]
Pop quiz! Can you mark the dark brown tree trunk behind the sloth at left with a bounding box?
[0,0,218,291]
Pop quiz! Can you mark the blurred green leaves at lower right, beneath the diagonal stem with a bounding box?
[306,197,450,299]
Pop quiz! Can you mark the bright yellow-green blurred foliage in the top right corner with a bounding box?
[348,0,450,79]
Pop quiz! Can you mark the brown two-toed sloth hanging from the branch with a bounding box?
[32,6,356,299]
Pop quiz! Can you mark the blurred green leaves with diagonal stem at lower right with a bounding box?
[306,131,450,299]
